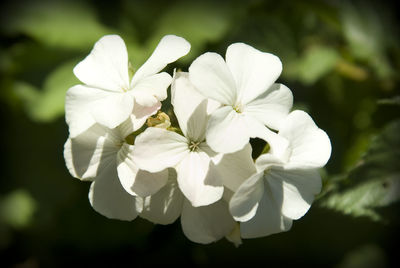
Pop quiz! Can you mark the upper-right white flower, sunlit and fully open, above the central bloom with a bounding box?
[189,43,293,153]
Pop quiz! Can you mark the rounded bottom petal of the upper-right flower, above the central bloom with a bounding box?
[206,106,250,153]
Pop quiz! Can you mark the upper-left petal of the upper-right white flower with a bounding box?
[189,52,236,105]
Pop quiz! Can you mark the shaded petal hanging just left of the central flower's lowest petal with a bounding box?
[140,169,184,224]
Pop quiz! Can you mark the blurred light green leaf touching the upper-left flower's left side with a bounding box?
[14,61,79,122]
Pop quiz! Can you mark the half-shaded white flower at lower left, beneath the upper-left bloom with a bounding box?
[64,119,168,220]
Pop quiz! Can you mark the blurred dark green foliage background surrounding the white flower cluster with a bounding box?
[0,0,400,268]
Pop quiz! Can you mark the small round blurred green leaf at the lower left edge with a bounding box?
[0,190,36,228]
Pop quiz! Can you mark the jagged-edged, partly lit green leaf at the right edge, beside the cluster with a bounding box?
[321,120,400,220]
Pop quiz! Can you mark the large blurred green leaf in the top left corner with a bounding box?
[7,1,112,50]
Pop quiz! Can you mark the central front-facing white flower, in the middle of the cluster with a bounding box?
[133,73,255,207]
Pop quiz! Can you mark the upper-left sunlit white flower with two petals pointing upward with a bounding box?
[65,35,190,137]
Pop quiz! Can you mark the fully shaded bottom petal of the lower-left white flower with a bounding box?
[89,160,141,221]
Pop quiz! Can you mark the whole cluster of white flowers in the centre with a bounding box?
[64,35,331,244]
